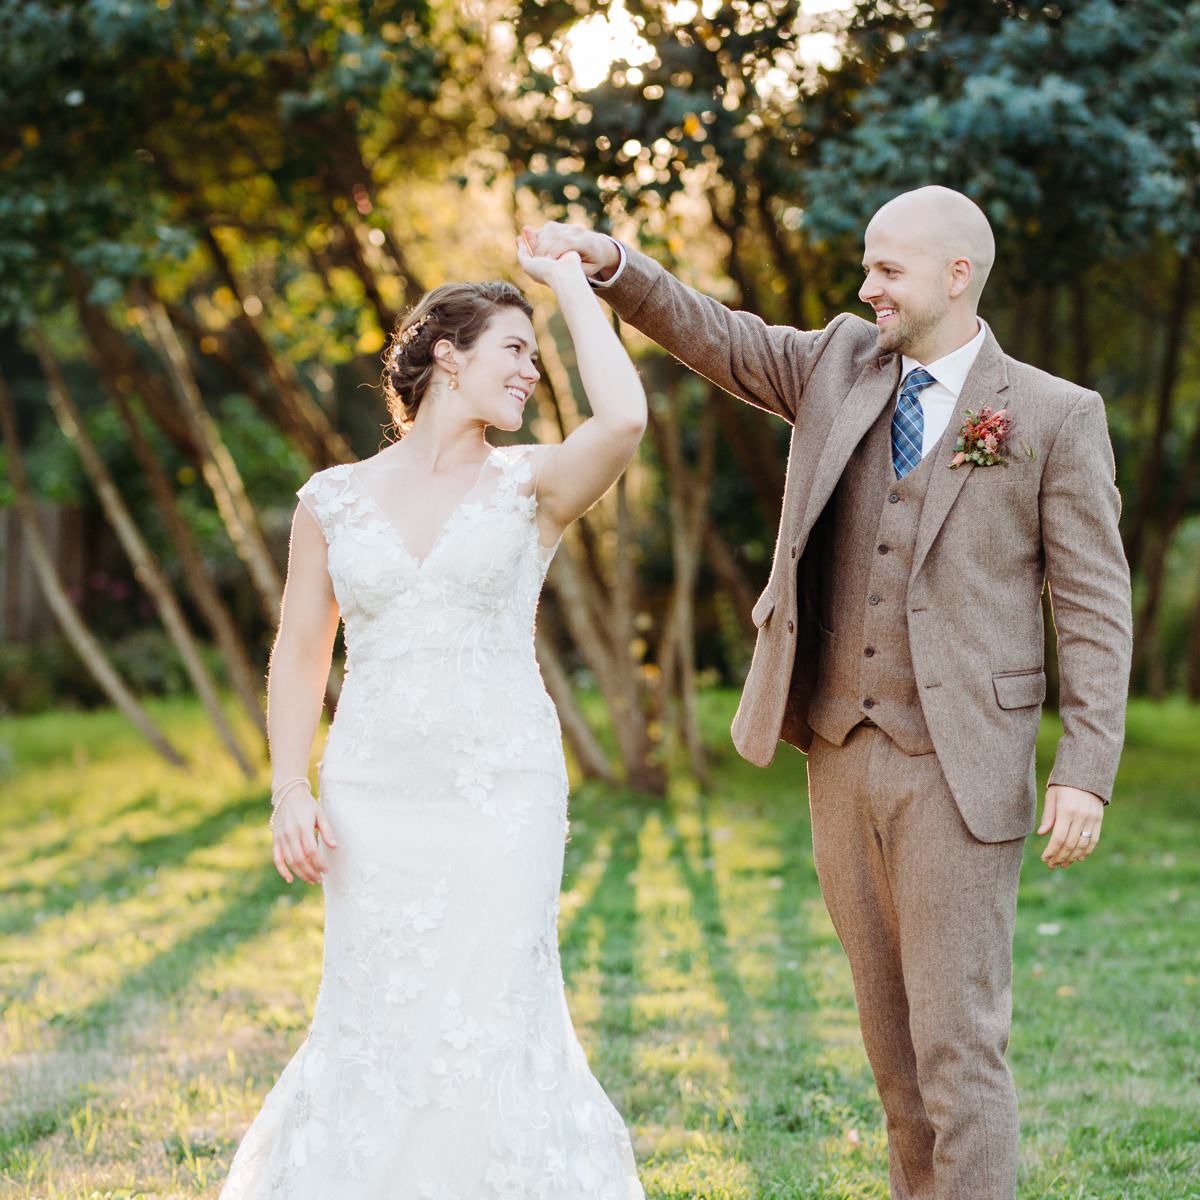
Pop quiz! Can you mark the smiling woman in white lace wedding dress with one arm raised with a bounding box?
[221,229,646,1200]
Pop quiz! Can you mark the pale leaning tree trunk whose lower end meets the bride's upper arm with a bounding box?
[139,295,283,624]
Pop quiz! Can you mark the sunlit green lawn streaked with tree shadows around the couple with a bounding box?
[0,694,1200,1200]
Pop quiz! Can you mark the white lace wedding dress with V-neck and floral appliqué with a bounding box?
[221,446,643,1200]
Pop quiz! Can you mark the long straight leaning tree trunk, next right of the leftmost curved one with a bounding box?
[29,325,254,779]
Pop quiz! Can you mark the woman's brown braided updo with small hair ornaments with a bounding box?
[383,281,533,433]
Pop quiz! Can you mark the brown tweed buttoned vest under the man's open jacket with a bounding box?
[809,403,941,754]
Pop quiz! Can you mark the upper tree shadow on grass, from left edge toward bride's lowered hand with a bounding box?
[0,792,264,936]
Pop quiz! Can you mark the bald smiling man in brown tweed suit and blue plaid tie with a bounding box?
[536,187,1130,1200]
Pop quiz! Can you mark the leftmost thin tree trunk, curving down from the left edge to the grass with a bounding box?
[0,362,187,767]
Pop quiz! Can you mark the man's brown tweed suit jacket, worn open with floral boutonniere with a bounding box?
[602,246,1132,841]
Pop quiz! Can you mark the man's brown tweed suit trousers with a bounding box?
[809,726,1025,1200]
